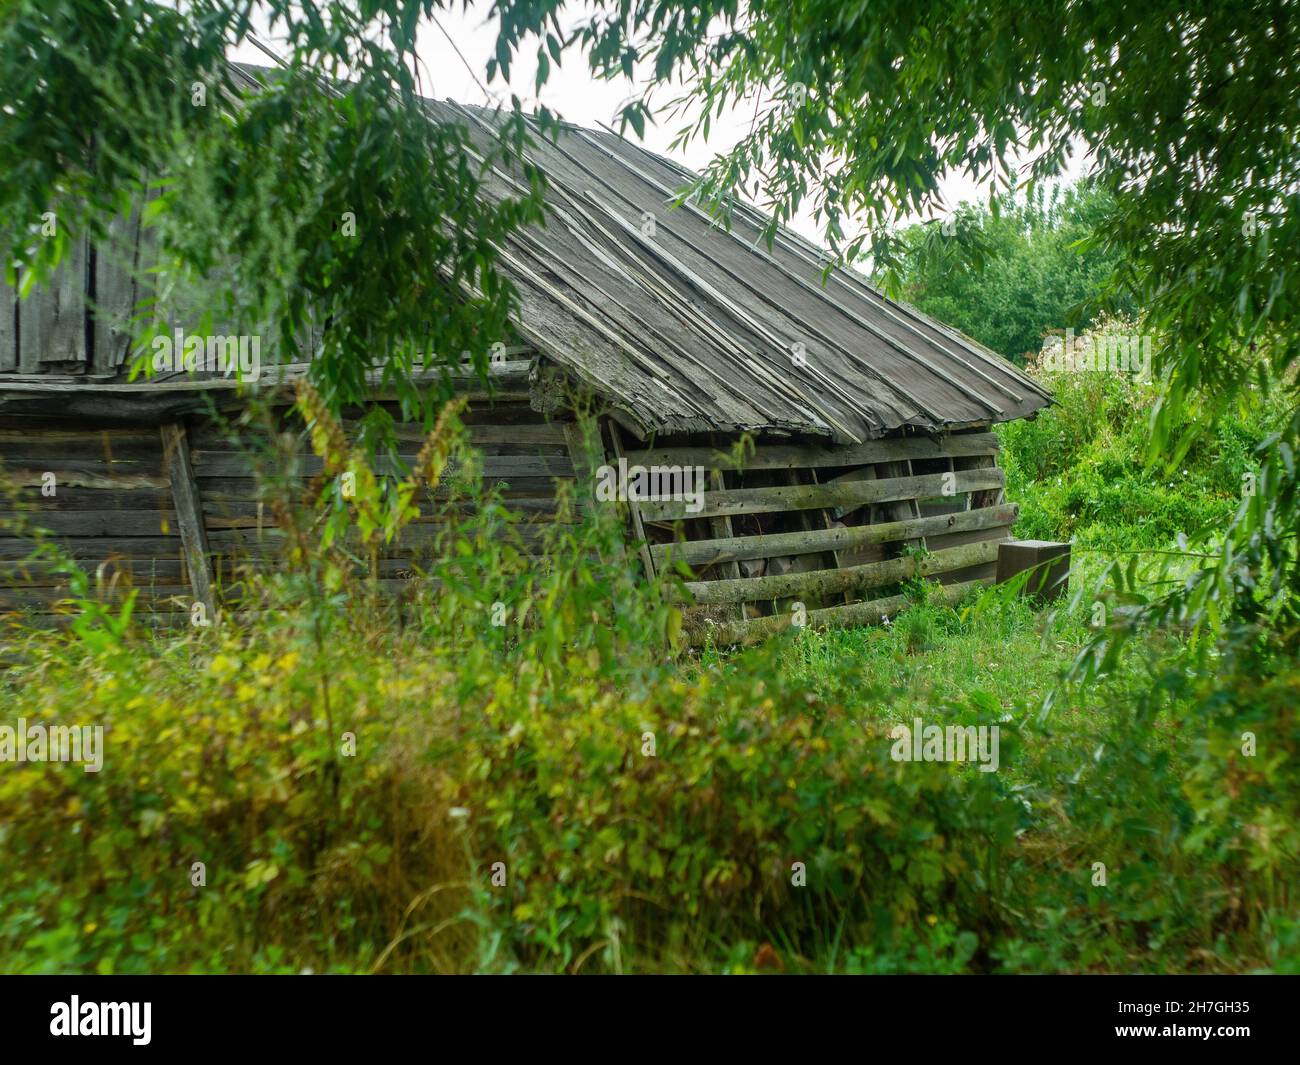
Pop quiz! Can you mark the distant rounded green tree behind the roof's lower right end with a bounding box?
[878,183,1135,362]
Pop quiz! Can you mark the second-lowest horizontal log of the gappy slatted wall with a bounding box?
[685,540,1000,603]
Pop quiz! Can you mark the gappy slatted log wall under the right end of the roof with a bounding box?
[610,427,1017,642]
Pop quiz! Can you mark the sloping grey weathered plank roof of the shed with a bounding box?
[429,103,1049,442]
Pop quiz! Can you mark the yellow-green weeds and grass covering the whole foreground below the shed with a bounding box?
[0,434,1300,973]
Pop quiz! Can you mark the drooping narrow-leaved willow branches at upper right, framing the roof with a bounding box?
[497,0,1300,702]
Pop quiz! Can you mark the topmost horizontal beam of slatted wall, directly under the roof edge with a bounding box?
[627,433,1000,469]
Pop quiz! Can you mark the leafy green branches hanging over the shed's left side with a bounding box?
[0,0,550,414]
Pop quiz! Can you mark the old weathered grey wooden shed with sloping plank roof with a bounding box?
[0,72,1048,641]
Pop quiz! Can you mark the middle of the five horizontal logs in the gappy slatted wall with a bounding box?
[650,503,1019,567]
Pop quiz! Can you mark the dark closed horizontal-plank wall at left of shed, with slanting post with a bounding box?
[0,402,573,625]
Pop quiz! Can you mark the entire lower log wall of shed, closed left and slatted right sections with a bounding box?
[0,398,1017,642]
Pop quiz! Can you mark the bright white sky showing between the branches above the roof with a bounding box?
[231,4,1086,244]
